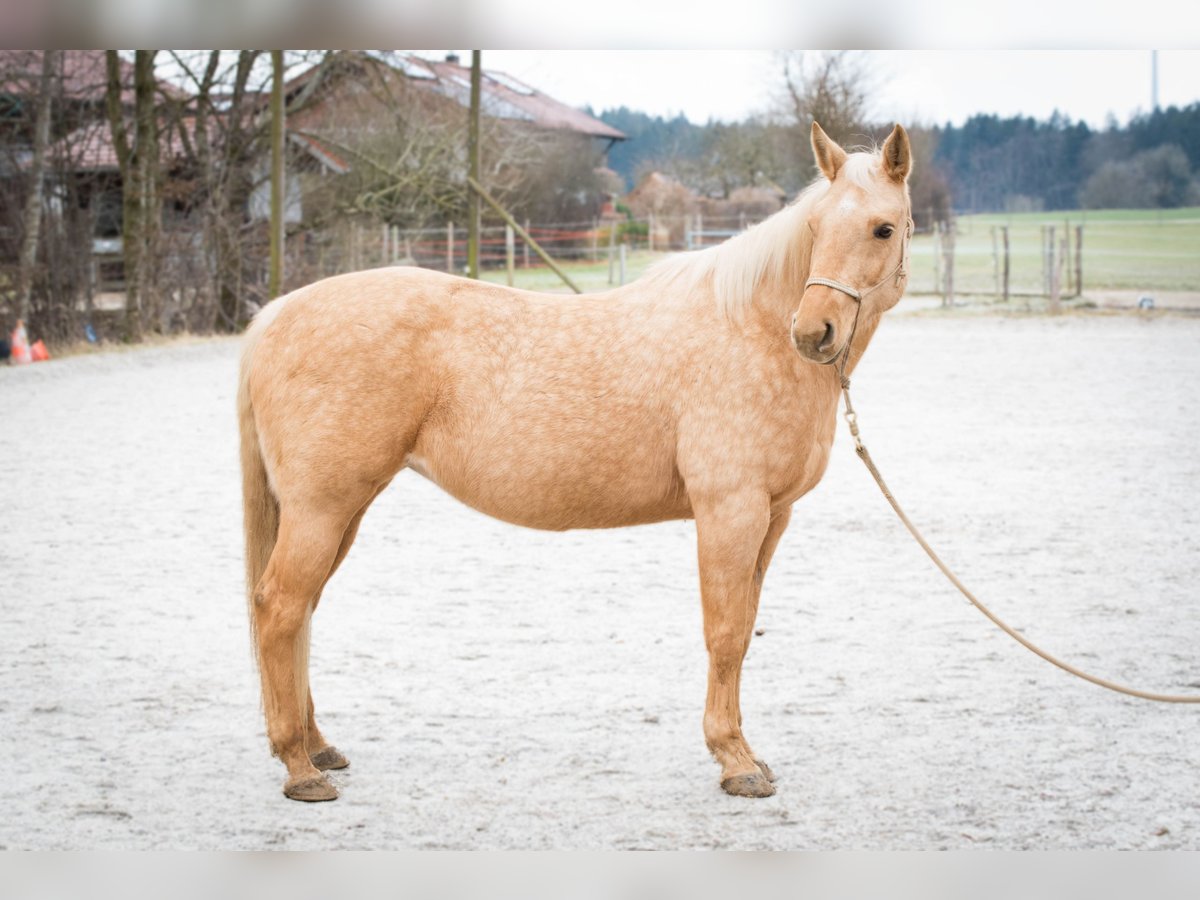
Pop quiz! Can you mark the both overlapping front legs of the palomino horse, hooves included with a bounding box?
[692,491,786,797]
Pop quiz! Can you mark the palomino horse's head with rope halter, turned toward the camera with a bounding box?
[792,122,912,364]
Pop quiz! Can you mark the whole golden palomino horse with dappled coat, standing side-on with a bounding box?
[238,124,911,800]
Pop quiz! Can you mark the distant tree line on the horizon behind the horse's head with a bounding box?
[598,91,1200,219]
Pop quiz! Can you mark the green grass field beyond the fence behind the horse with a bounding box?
[484,206,1200,296]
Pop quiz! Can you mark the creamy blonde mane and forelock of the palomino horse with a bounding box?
[644,151,880,320]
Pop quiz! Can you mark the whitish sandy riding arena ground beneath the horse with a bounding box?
[0,316,1200,850]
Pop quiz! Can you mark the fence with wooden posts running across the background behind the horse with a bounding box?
[75,209,1200,336]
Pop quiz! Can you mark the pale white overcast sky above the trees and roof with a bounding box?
[422,49,1200,127]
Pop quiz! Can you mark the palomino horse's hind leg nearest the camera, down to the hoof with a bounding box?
[254,506,348,800]
